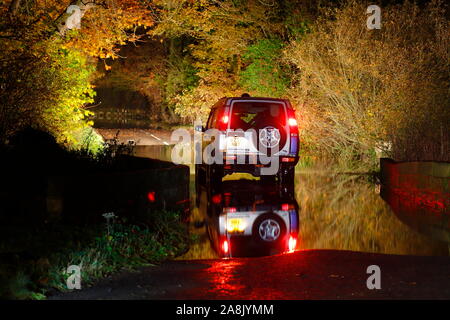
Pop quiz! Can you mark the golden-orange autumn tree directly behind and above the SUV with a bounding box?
[146,0,298,119]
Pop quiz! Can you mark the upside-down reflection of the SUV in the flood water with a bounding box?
[197,180,299,257]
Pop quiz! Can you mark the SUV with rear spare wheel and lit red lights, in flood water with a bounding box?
[195,96,299,183]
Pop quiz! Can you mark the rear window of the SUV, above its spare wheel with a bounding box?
[230,101,286,131]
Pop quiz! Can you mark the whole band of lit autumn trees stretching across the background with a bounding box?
[0,0,450,165]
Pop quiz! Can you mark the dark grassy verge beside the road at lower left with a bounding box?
[0,211,190,299]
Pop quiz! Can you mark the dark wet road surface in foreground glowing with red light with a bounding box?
[49,250,450,300]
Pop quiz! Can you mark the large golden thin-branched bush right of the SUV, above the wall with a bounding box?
[285,0,450,170]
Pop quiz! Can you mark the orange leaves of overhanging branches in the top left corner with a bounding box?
[0,0,153,58]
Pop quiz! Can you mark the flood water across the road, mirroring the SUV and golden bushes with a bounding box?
[137,146,450,259]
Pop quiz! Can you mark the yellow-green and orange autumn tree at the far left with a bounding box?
[0,0,153,146]
